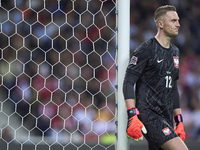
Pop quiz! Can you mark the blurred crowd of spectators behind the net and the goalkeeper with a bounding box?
[0,0,200,142]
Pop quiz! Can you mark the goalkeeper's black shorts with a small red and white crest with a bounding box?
[144,117,178,150]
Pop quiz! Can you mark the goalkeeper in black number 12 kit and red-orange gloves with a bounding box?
[123,5,188,150]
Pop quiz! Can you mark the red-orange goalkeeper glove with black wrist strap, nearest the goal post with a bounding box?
[126,107,147,142]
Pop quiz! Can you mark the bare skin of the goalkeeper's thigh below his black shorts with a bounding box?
[161,137,188,150]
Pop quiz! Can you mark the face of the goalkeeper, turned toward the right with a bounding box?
[162,11,180,37]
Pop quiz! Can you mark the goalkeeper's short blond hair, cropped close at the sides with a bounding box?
[154,5,177,23]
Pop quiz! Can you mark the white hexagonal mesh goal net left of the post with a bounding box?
[0,0,115,150]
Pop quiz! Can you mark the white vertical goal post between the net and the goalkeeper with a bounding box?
[116,0,130,150]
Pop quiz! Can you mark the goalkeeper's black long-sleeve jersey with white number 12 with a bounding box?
[123,38,179,125]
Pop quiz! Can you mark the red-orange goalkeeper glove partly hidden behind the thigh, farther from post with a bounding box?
[174,114,185,141]
